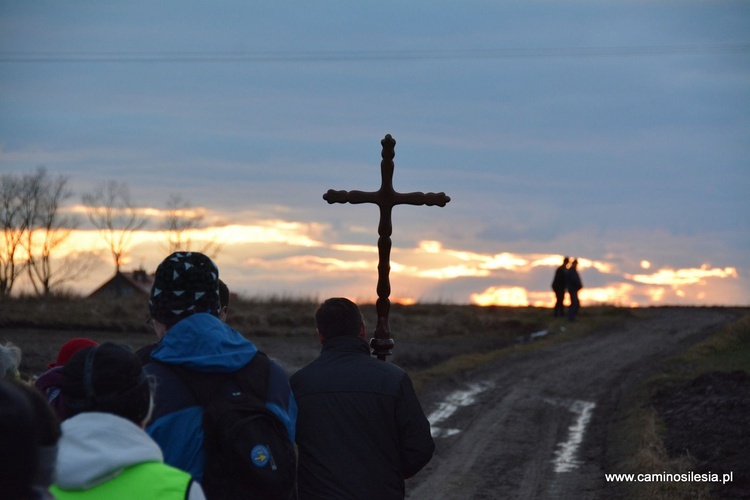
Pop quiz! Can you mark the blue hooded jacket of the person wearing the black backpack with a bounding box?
[144,313,297,481]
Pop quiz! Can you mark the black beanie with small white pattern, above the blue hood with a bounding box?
[148,252,221,327]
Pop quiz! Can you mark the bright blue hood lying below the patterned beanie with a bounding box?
[151,313,258,373]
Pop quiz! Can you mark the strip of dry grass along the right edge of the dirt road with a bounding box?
[608,309,750,500]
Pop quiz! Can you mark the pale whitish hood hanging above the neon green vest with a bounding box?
[56,412,164,490]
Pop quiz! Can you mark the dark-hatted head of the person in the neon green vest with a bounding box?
[62,342,151,425]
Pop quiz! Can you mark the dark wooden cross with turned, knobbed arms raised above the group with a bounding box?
[323,134,451,361]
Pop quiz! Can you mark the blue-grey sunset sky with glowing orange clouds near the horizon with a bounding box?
[0,0,750,306]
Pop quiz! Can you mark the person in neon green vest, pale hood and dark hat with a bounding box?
[50,343,205,500]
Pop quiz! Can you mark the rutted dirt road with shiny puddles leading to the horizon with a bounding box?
[407,308,733,500]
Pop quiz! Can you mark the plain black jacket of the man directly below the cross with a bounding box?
[291,337,435,500]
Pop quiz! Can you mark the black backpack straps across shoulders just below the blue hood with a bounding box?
[158,351,270,407]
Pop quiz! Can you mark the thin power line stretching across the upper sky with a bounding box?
[0,44,750,64]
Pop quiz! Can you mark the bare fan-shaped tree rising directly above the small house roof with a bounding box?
[81,180,146,272]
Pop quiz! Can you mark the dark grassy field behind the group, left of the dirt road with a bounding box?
[0,297,632,378]
